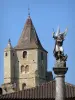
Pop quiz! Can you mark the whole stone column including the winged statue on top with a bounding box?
[52,26,68,100]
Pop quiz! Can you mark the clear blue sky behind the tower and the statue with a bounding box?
[0,0,75,84]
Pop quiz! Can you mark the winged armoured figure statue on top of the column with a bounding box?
[52,28,67,66]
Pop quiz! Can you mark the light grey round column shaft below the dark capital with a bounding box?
[55,75,65,100]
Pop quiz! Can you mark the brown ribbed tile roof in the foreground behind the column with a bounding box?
[0,81,75,100]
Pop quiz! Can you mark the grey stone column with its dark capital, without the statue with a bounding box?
[53,67,68,100]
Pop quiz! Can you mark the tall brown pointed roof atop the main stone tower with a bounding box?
[15,16,46,51]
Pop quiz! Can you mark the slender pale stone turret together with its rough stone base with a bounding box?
[1,39,15,94]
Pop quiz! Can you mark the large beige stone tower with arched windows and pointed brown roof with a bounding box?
[14,15,52,90]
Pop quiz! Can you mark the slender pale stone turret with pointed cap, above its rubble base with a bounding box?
[4,39,14,84]
